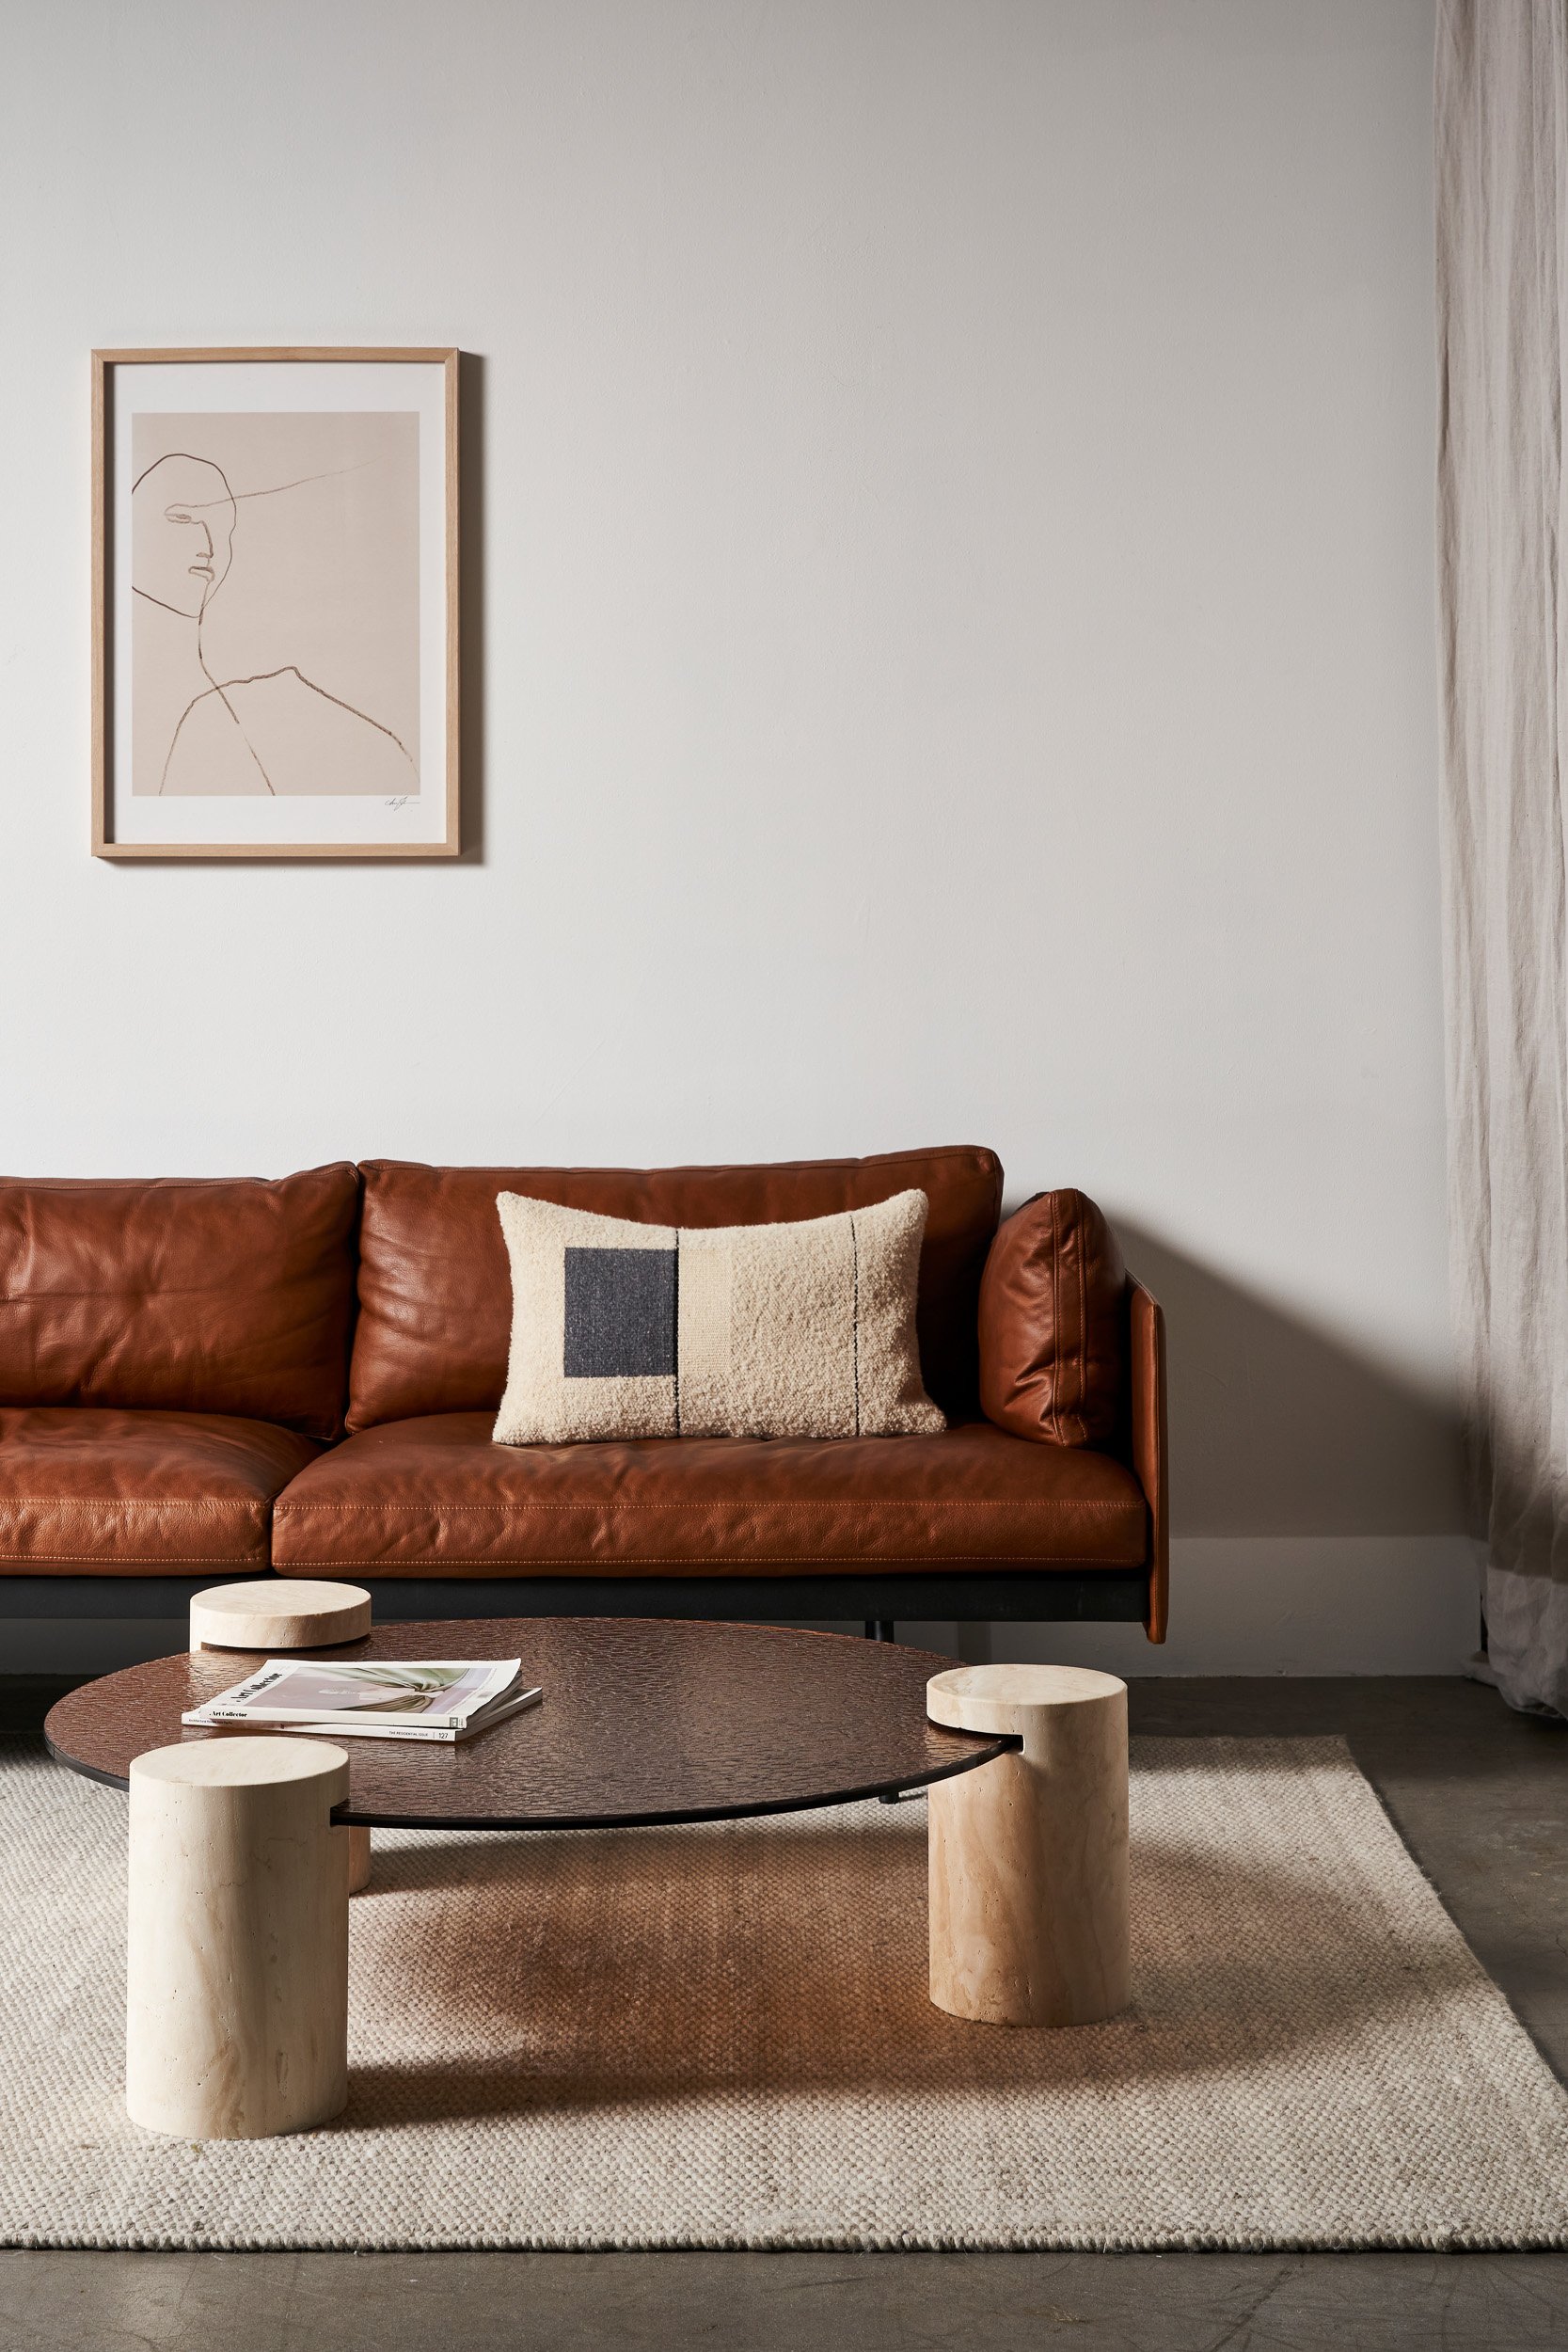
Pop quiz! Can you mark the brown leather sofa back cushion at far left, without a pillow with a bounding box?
[0,1162,359,1438]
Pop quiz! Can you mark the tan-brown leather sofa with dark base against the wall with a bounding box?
[0,1148,1168,1642]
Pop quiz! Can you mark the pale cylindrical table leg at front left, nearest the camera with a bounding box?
[124,1736,348,2140]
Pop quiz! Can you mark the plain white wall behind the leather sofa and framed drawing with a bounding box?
[0,0,1469,1670]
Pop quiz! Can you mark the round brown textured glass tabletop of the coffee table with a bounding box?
[44,1618,1018,1830]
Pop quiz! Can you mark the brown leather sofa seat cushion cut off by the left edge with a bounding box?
[0,1405,317,1576]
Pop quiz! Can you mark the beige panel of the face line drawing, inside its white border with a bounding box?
[129,417,419,800]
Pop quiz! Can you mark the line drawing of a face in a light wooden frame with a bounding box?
[91,351,458,859]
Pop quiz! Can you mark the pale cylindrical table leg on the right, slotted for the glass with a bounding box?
[927,1665,1131,2026]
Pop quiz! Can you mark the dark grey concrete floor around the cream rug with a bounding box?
[0,1679,1568,2352]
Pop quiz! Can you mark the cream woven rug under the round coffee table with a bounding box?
[0,1740,1568,2249]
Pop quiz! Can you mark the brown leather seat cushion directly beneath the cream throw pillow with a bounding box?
[273,1414,1148,1576]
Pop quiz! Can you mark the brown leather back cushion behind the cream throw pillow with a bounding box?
[348,1146,1002,1430]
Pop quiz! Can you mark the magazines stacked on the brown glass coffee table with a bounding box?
[181,1659,543,1740]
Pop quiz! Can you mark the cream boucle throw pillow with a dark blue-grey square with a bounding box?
[496,1193,945,1447]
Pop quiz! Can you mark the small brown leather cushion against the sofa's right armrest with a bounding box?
[980,1193,1129,1447]
